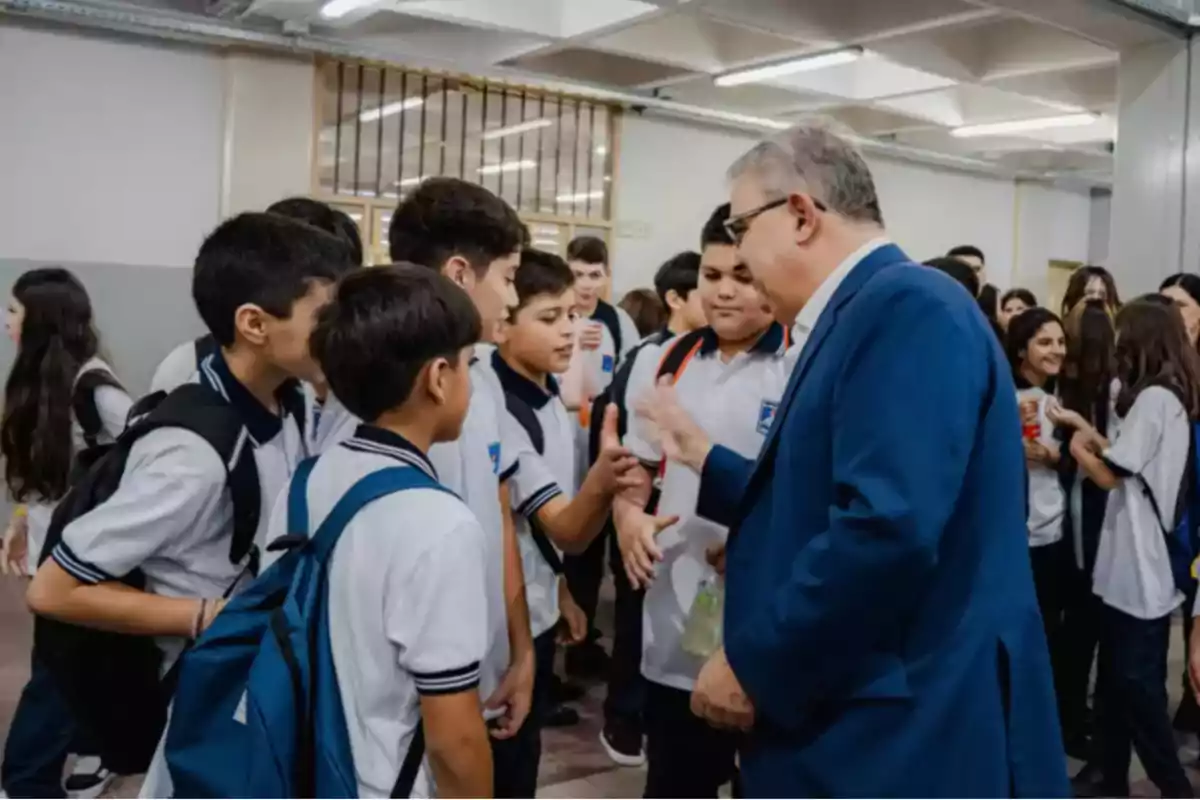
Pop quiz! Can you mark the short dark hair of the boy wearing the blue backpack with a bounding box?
[311,264,481,422]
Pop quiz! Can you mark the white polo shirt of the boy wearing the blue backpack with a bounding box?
[262,425,492,798]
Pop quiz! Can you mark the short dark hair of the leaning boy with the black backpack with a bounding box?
[192,212,355,347]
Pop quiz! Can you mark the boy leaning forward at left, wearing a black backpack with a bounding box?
[28,213,353,796]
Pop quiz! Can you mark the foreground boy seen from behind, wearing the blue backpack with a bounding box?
[271,265,496,798]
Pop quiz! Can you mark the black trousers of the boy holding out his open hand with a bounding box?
[492,628,554,798]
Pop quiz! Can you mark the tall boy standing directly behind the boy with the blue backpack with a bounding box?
[316,178,534,798]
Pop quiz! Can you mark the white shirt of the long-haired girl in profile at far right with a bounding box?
[1092,386,1192,620]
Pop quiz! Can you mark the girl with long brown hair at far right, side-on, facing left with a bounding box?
[1056,299,1200,798]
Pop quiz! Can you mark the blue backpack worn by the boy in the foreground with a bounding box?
[166,459,449,798]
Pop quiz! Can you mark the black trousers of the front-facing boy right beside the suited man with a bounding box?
[644,681,739,798]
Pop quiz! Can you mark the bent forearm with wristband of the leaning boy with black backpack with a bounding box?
[25,559,200,636]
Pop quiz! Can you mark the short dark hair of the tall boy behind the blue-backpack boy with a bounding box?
[388,178,528,275]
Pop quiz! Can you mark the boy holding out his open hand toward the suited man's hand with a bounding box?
[492,249,637,796]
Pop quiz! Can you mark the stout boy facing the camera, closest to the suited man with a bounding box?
[613,205,788,798]
